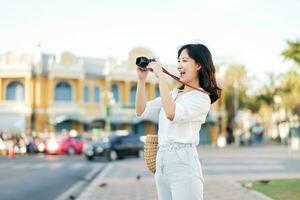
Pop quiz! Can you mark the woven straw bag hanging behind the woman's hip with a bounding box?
[144,134,158,173]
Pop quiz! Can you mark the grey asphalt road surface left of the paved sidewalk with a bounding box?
[0,155,103,200]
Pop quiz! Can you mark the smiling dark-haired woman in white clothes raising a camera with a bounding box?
[136,44,221,200]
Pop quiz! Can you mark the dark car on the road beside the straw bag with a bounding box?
[83,135,144,160]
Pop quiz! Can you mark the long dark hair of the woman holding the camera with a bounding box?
[177,44,221,103]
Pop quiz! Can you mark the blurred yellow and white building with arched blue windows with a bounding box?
[0,48,178,137]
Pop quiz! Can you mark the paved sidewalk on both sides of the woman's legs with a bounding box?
[77,151,270,200]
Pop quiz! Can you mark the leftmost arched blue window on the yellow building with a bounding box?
[6,81,24,101]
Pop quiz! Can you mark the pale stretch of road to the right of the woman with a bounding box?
[198,145,300,180]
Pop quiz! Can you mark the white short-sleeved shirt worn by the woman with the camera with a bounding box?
[137,88,211,145]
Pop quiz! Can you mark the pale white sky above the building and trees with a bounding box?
[0,0,300,84]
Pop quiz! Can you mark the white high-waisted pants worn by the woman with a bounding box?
[154,143,204,200]
